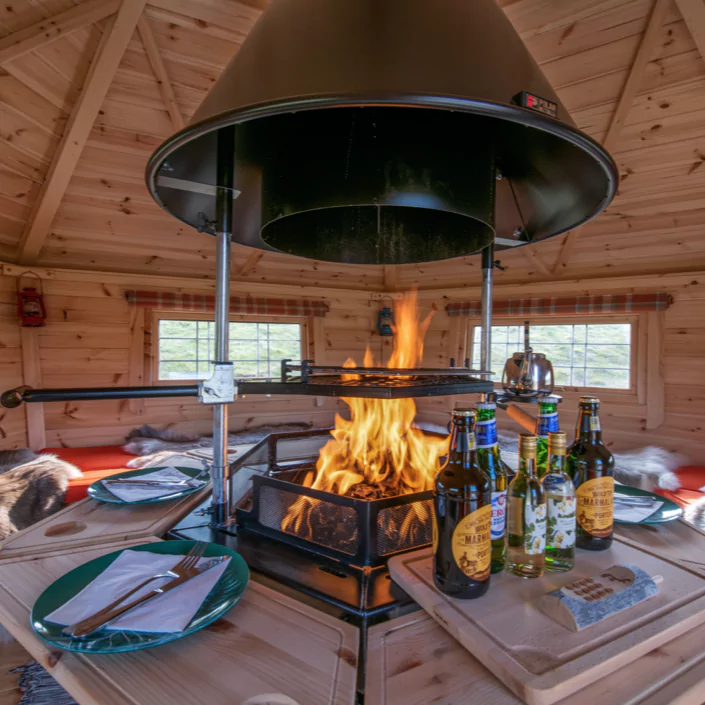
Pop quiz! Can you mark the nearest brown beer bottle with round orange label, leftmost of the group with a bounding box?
[433,409,492,599]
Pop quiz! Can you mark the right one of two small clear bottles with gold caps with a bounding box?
[542,431,575,573]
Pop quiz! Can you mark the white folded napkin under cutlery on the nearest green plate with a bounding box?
[46,550,230,633]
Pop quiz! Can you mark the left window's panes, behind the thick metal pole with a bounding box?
[157,314,302,381]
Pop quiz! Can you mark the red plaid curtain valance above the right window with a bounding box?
[446,293,673,317]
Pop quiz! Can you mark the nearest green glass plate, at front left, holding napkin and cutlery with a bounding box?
[30,541,250,654]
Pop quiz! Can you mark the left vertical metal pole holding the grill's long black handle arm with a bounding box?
[211,127,235,525]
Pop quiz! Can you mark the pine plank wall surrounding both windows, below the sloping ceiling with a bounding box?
[0,263,705,461]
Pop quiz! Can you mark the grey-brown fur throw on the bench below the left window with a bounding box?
[123,423,311,468]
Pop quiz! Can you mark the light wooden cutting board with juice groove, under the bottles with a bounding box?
[389,540,705,705]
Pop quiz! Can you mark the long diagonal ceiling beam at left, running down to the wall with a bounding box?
[18,0,147,264]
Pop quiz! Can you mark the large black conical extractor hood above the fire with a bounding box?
[147,0,618,264]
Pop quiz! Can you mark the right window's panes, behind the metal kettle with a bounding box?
[472,323,633,389]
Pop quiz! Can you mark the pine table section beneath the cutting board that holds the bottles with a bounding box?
[365,611,705,705]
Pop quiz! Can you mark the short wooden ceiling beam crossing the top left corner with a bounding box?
[0,0,120,64]
